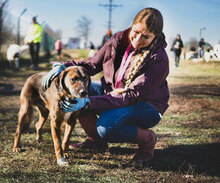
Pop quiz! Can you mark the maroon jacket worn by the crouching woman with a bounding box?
[65,29,169,114]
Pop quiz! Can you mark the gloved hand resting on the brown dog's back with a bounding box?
[42,64,66,91]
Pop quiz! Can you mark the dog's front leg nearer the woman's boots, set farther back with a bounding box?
[62,118,76,158]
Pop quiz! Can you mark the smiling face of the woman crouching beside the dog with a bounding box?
[129,23,155,49]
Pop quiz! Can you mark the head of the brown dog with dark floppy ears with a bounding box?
[56,66,91,99]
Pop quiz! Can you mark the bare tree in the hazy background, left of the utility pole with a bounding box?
[76,16,91,48]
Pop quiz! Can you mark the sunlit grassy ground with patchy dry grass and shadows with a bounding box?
[0,53,220,183]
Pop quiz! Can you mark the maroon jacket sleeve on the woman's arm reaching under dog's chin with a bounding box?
[90,52,169,110]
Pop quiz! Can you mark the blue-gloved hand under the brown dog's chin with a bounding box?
[59,98,90,112]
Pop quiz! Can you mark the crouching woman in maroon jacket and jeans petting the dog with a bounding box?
[42,8,169,162]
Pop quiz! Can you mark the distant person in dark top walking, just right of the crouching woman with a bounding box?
[172,34,183,67]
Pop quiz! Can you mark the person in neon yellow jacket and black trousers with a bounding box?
[24,17,43,70]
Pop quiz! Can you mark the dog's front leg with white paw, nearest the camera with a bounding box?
[51,119,68,166]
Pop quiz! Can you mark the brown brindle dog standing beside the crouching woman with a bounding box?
[13,66,91,166]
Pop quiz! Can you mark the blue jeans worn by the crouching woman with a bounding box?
[90,83,161,143]
